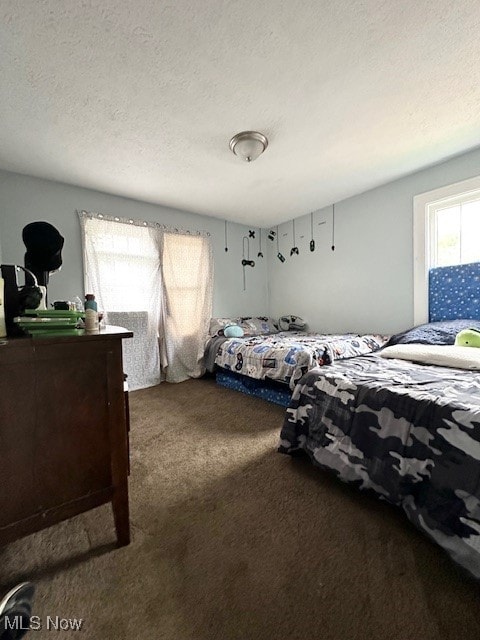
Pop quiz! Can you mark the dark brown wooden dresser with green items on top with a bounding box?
[0,327,132,545]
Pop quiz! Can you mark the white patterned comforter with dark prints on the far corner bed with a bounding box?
[215,331,387,389]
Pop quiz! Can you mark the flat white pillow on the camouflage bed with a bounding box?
[379,344,480,370]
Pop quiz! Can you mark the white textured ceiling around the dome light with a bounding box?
[0,0,480,226]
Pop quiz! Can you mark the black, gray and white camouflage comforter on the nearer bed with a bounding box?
[279,354,480,579]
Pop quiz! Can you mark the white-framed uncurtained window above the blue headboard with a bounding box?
[413,176,480,324]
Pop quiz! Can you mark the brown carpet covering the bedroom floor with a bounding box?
[0,380,480,640]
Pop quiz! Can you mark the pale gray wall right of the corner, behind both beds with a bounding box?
[268,149,480,333]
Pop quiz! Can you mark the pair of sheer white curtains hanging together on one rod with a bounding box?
[79,212,213,389]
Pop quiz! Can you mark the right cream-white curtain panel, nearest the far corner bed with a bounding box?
[162,231,213,382]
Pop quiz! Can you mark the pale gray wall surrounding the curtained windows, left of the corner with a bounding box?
[0,171,268,316]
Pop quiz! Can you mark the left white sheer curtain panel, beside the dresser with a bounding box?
[80,214,162,389]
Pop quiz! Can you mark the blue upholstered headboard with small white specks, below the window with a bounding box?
[428,262,480,322]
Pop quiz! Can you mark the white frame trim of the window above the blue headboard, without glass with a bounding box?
[413,176,480,325]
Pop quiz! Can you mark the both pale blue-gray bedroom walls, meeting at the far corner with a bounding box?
[0,144,480,333]
